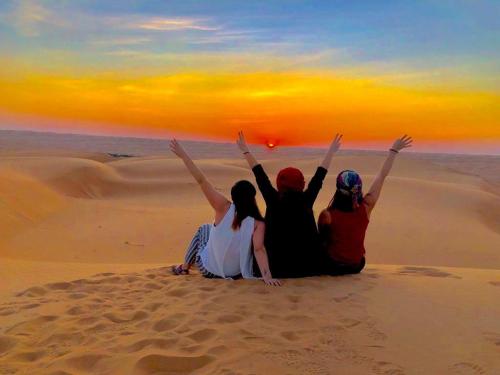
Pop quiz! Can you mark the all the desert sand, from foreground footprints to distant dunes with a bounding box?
[0,132,500,375]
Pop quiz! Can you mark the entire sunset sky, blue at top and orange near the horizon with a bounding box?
[0,0,500,153]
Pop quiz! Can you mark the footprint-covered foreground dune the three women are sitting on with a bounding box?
[0,266,500,374]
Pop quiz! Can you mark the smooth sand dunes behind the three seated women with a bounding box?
[0,156,500,269]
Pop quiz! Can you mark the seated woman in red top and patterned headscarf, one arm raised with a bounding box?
[318,135,412,275]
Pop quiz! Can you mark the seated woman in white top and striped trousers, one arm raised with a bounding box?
[170,139,280,286]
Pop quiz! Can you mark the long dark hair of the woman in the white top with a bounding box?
[231,180,264,230]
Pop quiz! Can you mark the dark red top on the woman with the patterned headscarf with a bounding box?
[327,203,369,265]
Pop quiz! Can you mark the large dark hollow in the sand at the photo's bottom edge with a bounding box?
[134,354,213,375]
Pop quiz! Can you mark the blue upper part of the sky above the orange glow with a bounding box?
[0,0,500,91]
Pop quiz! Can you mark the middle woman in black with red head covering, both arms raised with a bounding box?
[237,132,342,278]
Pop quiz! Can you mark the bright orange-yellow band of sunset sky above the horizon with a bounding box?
[0,71,500,145]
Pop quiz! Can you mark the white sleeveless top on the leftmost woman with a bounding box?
[200,203,255,279]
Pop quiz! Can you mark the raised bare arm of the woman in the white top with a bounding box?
[170,139,231,216]
